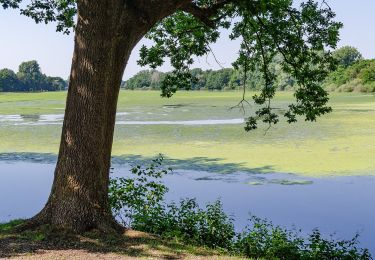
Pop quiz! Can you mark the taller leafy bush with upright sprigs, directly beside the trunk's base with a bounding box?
[109,155,235,248]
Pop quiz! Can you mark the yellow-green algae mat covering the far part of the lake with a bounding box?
[0,91,375,177]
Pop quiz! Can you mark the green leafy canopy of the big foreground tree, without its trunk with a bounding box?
[0,0,342,131]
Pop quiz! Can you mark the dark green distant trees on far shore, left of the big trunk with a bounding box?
[0,60,67,92]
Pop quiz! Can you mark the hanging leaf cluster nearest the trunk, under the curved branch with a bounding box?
[138,11,224,97]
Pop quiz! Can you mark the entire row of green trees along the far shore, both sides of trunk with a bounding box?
[0,46,375,92]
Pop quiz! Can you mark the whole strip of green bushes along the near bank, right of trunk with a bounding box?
[109,156,372,260]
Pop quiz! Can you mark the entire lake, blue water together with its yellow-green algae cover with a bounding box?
[0,91,375,254]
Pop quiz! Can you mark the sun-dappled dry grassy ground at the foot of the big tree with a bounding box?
[0,220,239,259]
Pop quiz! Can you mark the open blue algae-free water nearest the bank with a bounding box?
[0,161,375,254]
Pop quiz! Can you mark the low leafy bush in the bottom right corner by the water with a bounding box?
[234,217,372,260]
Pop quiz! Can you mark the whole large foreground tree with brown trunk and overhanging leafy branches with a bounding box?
[0,0,341,232]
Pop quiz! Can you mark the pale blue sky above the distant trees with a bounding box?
[0,0,375,80]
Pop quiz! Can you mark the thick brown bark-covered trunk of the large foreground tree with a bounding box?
[27,1,145,232]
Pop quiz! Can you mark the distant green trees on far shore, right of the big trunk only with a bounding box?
[122,46,375,92]
